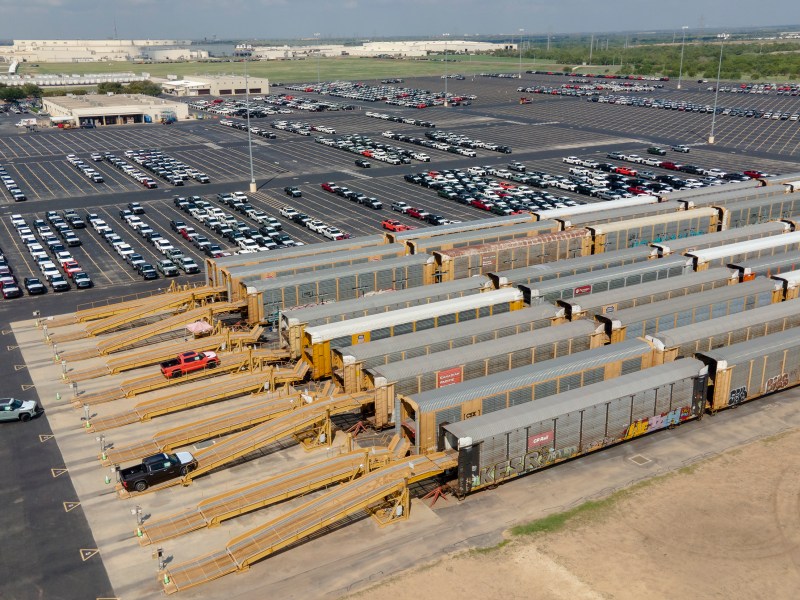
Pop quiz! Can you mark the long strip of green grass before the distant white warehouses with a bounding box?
[20,56,563,82]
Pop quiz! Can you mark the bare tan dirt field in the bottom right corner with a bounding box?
[351,430,800,600]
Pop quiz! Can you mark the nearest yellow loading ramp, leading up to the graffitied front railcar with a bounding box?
[159,453,456,594]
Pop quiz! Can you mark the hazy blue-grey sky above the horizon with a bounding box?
[0,0,800,40]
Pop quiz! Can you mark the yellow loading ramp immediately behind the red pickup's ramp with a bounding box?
[67,327,276,382]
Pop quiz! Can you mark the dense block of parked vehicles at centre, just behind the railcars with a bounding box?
[400,163,581,216]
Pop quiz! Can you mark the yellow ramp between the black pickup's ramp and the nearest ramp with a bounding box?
[139,447,392,546]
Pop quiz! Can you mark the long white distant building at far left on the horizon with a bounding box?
[0,40,208,63]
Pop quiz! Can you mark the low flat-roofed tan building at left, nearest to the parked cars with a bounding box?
[42,94,189,127]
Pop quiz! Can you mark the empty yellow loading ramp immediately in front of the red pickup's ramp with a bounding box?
[86,365,307,432]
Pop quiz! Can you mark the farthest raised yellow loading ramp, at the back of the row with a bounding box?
[50,287,226,343]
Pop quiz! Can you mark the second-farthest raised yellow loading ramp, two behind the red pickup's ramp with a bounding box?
[61,302,245,362]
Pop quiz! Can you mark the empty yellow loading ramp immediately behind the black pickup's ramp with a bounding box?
[103,387,301,465]
